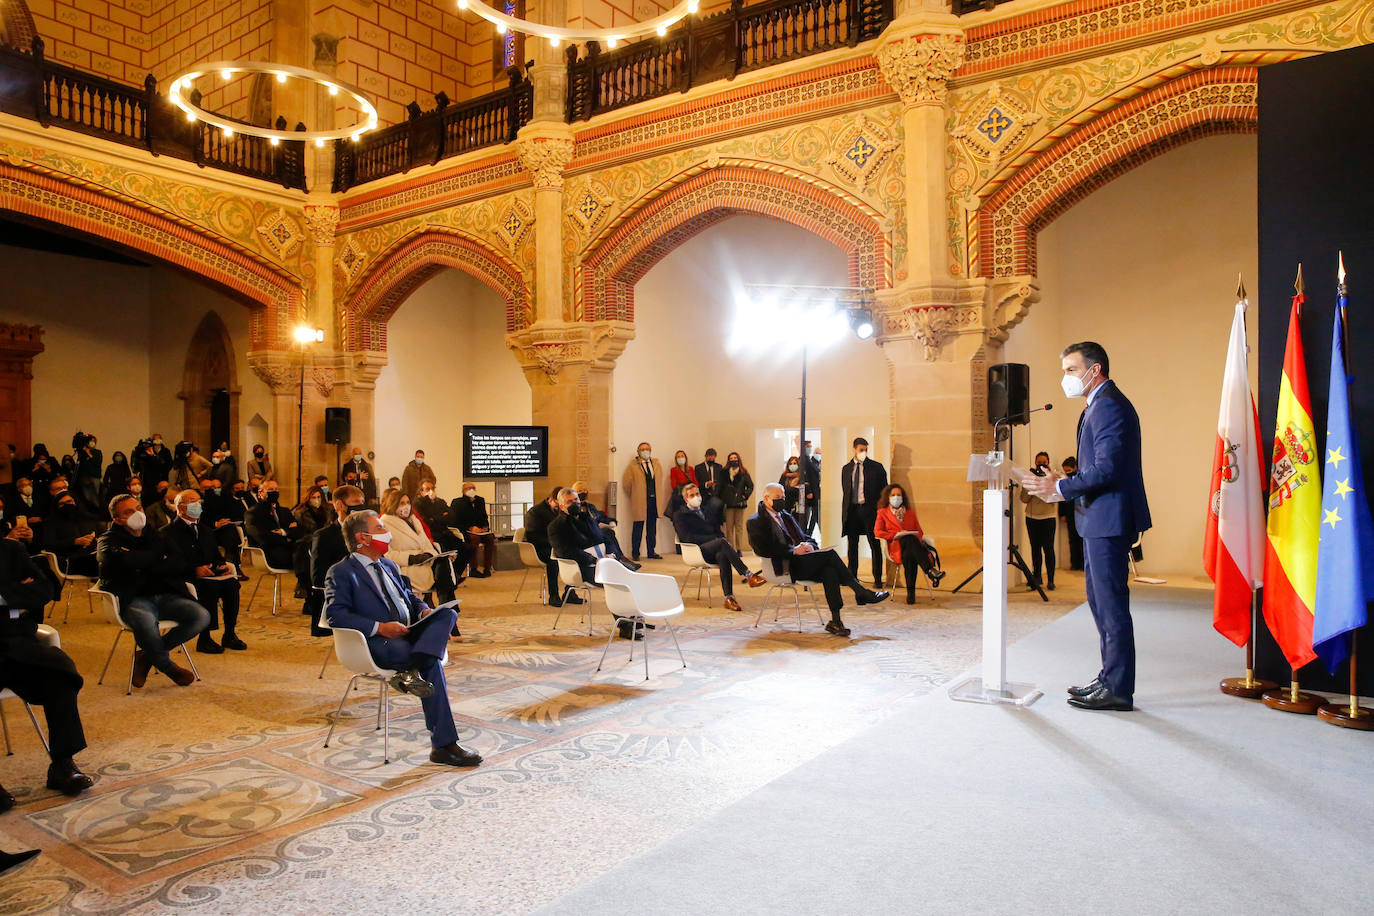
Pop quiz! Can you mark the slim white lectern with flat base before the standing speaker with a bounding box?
[948,452,1043,706]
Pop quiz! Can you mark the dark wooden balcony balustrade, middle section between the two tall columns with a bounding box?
[334,67,534,192]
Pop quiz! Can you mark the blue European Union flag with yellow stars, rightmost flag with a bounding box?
[1312,287,1374,674]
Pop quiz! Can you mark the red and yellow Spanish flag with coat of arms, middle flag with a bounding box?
[1263,291,1322,672]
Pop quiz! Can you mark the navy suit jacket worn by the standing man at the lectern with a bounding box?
[1059,379,1150,540]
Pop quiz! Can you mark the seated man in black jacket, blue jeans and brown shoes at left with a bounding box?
[96,494,210,687]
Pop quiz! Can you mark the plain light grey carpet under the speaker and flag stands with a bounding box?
[540,586,1374,915]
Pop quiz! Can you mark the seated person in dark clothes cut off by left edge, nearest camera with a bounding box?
[0,540,92,813]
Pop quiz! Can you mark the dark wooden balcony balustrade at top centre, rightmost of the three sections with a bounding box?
[566,0,893,121]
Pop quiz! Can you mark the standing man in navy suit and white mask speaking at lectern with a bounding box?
[1021,341,1150,711]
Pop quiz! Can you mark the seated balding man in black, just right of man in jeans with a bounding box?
[162,490,247,655]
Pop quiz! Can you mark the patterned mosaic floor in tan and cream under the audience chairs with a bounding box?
[0,559,1083,915]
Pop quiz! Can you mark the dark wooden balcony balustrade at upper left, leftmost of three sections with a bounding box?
[0,38,305,191]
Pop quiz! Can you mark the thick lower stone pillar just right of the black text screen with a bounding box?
[506,321,635,505]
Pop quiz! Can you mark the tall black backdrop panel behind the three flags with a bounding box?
[1256,47,1374,686]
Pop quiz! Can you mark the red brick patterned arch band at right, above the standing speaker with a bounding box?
[973,66,1259,277]
